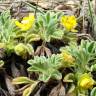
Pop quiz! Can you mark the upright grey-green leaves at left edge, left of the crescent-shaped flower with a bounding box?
[0,11,16,43]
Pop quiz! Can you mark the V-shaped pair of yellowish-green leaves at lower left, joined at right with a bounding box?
[12,77,39,96]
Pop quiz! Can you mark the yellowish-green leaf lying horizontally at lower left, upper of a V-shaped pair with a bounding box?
[12,77,35,84]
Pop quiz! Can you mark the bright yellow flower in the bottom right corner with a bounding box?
[78,73,94,89]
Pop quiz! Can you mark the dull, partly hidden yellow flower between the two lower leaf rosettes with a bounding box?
[61,51,75,64]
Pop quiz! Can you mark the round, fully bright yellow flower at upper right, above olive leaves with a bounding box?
[60,15,77,32]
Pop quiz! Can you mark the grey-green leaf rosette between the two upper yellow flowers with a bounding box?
[34,12,63,42]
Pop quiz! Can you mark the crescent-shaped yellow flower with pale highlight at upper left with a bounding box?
[15,13,35,31]
